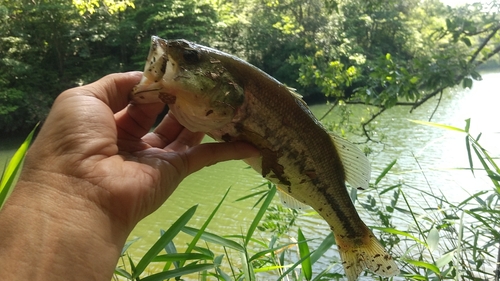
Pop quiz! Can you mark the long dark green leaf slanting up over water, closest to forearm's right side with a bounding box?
[132,205,198,278]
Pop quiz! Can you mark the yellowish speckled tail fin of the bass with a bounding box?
[335,232,399,281]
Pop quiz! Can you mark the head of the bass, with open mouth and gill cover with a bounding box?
[132,36,245,132]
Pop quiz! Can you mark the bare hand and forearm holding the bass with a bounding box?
[0,72,259,281]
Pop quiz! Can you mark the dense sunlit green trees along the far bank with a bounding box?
[0,0,500,134]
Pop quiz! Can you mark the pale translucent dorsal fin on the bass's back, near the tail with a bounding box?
[330,134,371,188]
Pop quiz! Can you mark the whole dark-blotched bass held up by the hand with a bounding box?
[130,36,399,281]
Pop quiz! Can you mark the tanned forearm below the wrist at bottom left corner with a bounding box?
[0,174,127,281]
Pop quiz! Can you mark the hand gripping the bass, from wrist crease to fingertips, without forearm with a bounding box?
[26,73,258,228]
